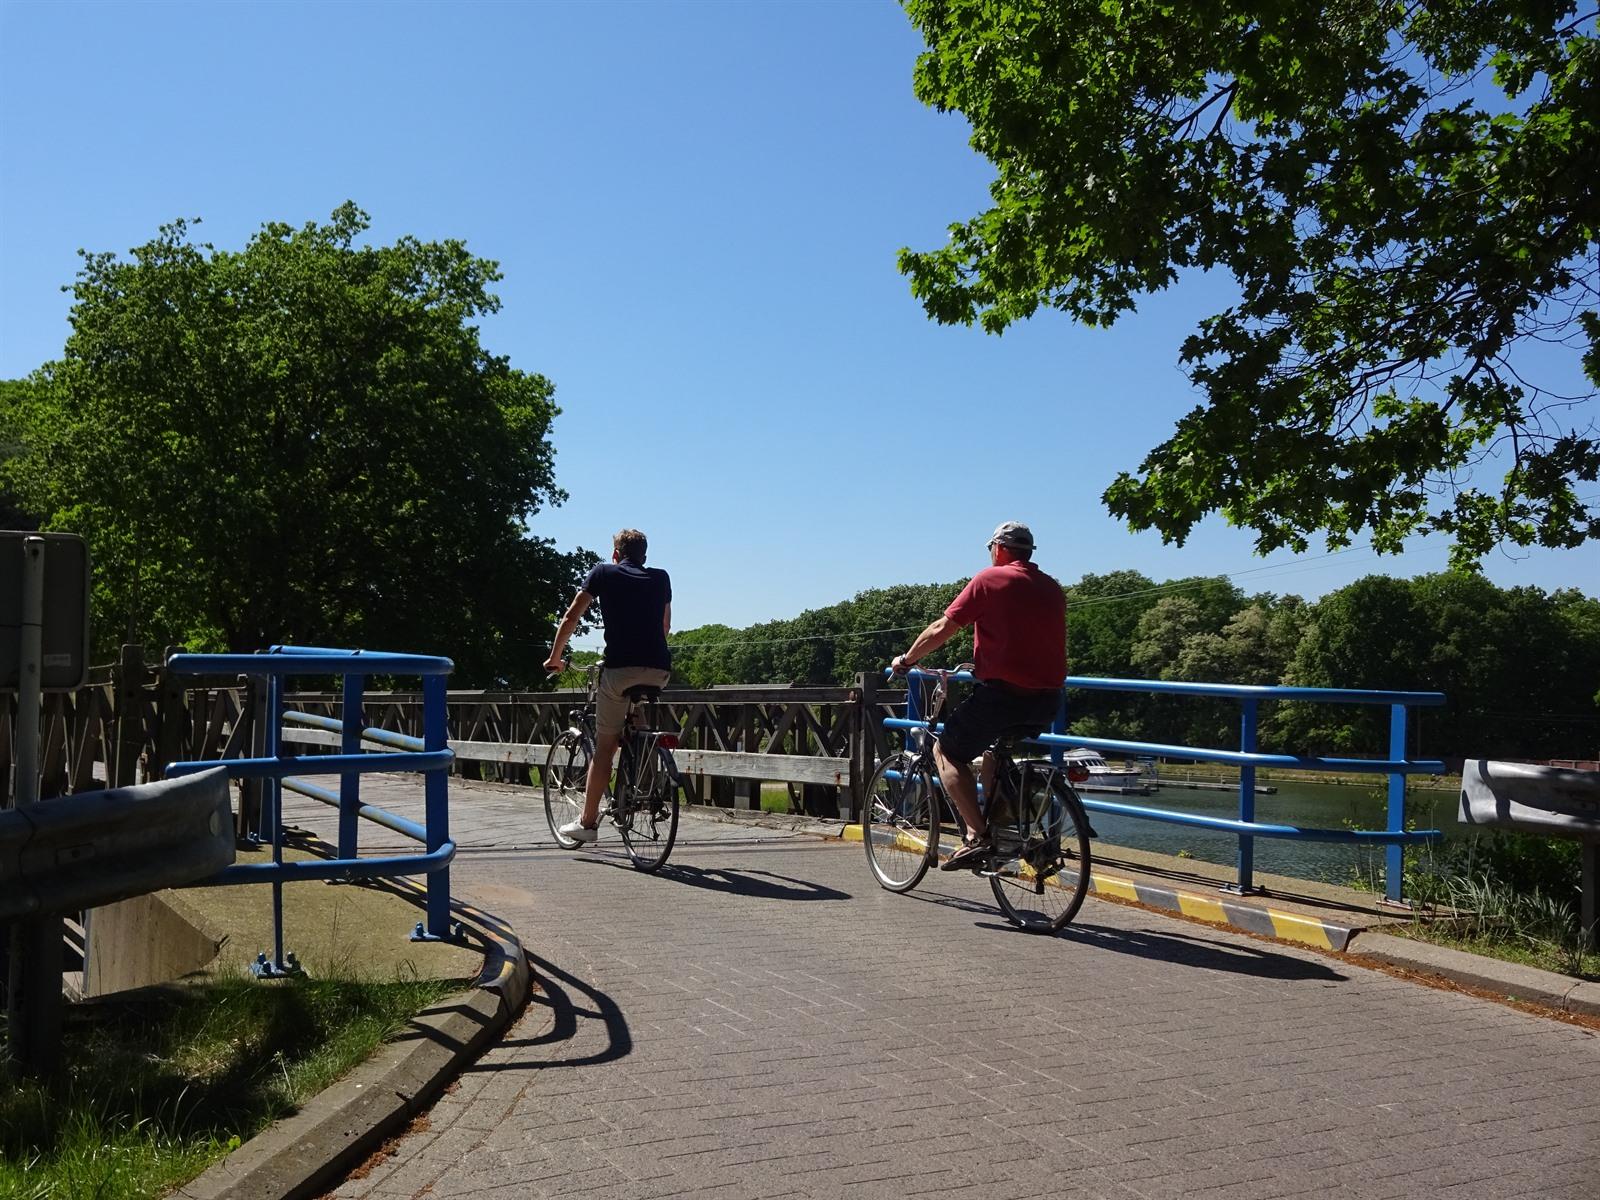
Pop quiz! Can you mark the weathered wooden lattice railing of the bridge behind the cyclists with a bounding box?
[0,646,904,829]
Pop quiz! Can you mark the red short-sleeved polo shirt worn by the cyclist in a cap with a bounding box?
[944,562,1067,690]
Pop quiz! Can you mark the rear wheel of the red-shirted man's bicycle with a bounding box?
[989,770,1090,933]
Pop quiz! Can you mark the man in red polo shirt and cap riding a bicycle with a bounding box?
[893,522,1067,870]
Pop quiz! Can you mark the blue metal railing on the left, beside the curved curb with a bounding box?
[166,646,458,976]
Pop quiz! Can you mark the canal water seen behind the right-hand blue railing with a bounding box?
[1083,776,1458,885]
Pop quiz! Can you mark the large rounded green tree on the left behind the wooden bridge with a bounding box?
[5,203,590,683]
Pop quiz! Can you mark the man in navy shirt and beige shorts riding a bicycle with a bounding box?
[544,530,672,842]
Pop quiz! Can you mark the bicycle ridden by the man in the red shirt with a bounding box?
[861,662,1090,933]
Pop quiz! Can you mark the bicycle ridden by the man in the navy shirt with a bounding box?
[542,662,682,872]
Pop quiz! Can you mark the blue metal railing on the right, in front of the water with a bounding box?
[883,670,1445,902]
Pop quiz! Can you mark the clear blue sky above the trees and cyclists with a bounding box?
[0,0,1600,649]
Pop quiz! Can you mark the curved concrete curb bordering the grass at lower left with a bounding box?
[171,886,528,1200]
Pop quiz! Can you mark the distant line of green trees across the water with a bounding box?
[672,571,1600,758]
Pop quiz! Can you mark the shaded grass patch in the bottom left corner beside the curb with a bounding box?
[0,978,461,1200]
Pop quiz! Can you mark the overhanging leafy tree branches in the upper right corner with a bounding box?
[901,0,1600,566]
